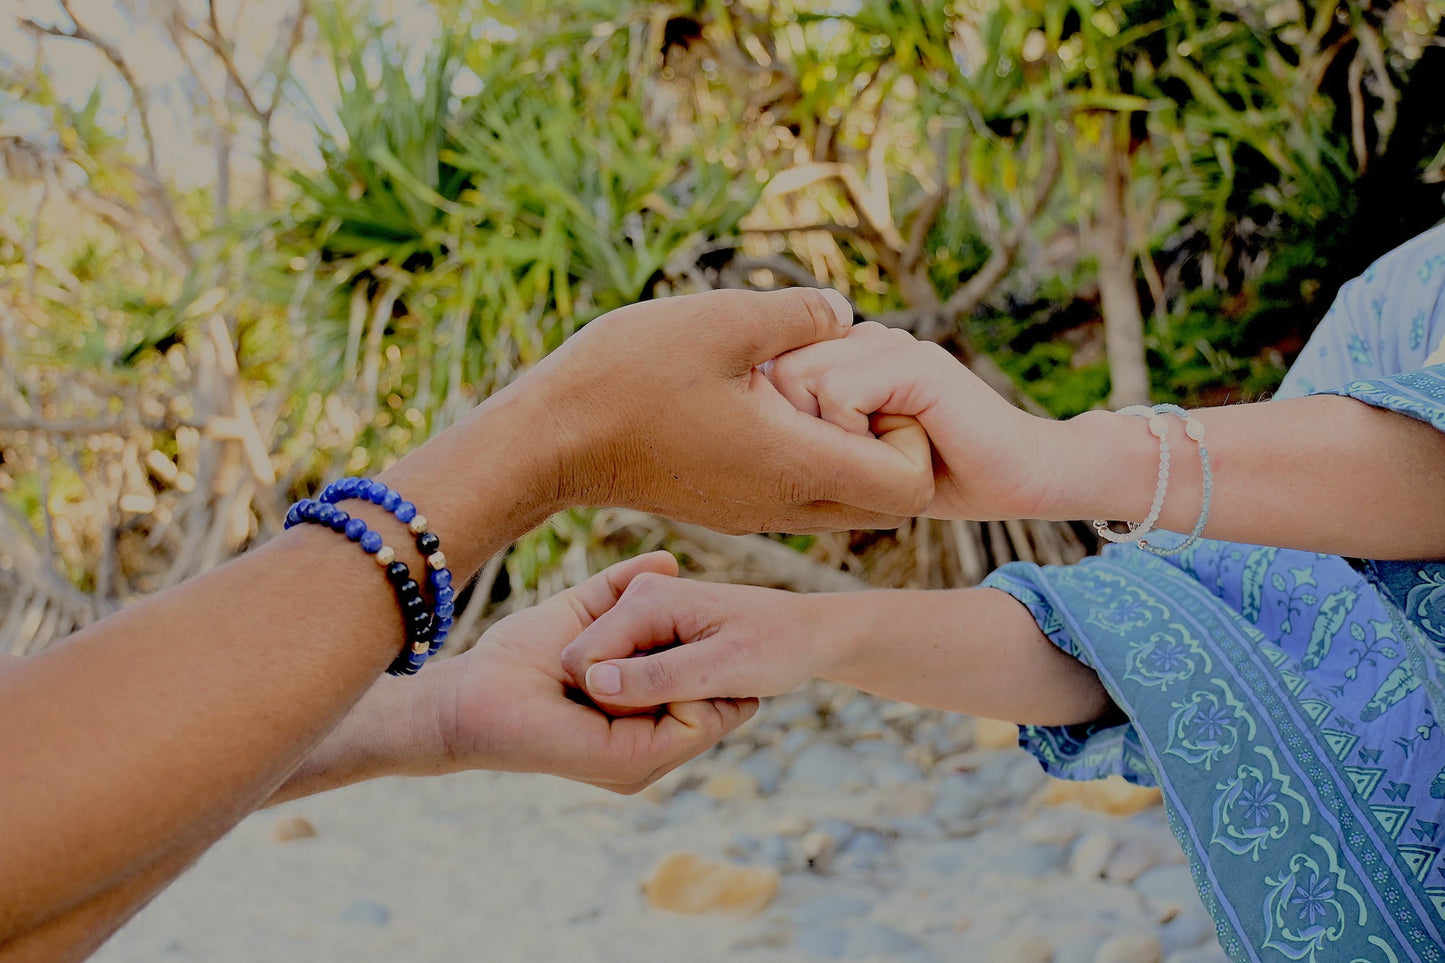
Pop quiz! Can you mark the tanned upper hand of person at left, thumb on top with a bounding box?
[514,288,932,532]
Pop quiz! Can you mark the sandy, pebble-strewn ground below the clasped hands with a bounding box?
[95,685,1224,963]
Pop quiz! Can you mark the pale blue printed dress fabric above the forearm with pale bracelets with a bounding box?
[1276,224,1445,398]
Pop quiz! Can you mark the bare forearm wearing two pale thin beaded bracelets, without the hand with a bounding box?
[1040,395,1445,558]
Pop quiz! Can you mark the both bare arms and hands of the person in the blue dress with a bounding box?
[564,324,1445,724]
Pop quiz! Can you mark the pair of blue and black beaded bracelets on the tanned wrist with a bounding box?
[286,477,457,675]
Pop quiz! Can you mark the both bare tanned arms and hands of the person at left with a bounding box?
[0,291,932,960]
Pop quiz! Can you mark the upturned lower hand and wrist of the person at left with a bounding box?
[284,552,757,804]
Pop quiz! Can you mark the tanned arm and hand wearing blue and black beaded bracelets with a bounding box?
[0,284,932,947]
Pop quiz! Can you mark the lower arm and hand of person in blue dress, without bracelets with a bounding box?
[562,575,1113,724]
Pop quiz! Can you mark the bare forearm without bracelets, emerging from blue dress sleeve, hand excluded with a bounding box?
[799,589,1113,724]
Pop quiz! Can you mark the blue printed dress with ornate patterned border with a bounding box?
[984,227,1445,963]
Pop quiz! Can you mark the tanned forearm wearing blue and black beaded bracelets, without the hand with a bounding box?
[0,387,551,943]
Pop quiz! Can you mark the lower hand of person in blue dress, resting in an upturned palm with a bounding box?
[562,573,835,716]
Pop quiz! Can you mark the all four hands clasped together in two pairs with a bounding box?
[311,289,1049,792]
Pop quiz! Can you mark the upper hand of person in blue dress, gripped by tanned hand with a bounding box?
[767,321,1062,521]
